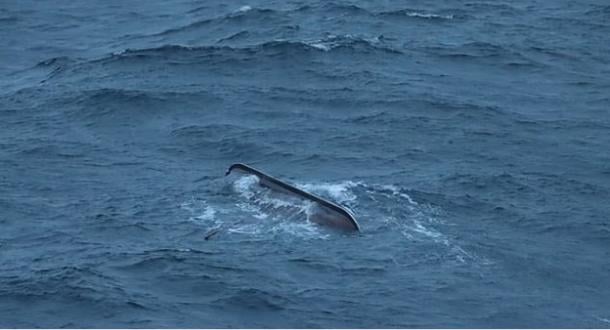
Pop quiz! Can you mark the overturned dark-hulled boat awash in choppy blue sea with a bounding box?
[225,163,360,231]
